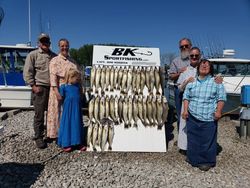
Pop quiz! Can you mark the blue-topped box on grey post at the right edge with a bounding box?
[240,85,250,139]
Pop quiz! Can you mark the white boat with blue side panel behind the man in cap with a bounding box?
[0,44,36,108]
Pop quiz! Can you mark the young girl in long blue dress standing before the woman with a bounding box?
[58,68,86,152]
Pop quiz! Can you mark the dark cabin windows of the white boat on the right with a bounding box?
[213,62,250,76]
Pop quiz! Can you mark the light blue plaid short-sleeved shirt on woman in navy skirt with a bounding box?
[183,76,226,121]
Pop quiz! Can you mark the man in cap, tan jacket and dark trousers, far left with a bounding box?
[23,33,56,149]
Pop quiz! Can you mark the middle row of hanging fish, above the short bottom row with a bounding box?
[88,95,168,127]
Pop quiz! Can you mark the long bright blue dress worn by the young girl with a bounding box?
[58,84,84,147]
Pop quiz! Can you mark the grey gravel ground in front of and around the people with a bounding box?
[0,111,250,188]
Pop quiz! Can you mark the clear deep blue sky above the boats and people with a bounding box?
[0,0,250,58]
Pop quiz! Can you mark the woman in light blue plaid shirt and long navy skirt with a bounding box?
[182,59,226,171]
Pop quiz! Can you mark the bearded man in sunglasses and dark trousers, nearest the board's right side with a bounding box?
[169,38,192,131]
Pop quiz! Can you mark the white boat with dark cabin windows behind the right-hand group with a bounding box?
[167,50,250,115]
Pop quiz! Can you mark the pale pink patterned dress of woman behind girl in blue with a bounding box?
[47,54,77,138]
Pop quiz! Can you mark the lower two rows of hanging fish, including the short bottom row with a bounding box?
[87,95,168,151]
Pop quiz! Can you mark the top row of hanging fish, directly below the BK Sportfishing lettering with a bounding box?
[90,66,164,94]
